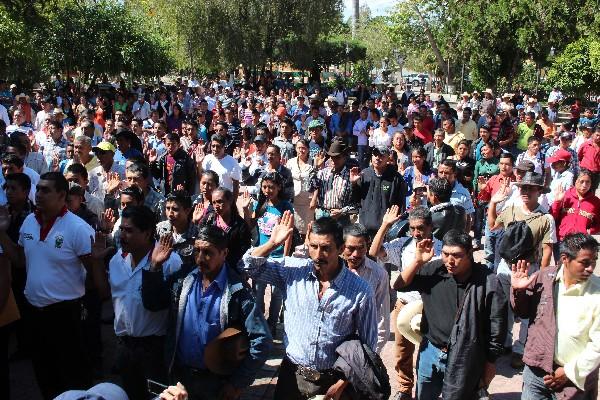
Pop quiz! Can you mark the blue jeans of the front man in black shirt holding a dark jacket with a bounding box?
[417,339,448,400]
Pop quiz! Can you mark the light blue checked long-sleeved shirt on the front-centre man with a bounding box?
[242,249,377,371]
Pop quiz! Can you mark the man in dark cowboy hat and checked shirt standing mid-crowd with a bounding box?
[311,138,357,225]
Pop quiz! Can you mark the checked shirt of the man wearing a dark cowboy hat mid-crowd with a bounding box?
[311,166,356,210]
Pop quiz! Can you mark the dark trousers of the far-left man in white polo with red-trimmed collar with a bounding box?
[26,299,92,399]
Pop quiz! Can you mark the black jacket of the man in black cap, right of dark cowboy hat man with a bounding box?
[352,165,407,231]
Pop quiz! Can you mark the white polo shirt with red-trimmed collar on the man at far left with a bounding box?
[19,211,94,307]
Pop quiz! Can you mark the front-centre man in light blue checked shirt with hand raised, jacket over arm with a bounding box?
[243,211,377,400]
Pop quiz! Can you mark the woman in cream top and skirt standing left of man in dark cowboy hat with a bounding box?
[286,139,316,236]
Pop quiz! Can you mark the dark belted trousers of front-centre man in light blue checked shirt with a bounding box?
[273,357,349,400]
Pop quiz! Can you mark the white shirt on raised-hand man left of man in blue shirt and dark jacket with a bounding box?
[108,249,182,337]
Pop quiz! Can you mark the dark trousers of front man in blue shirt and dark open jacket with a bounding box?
[170,365,228,400]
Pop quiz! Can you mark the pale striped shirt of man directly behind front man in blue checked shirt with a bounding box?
[350,257,390,353]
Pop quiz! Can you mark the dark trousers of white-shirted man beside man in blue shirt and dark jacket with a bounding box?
[116,336,167,400]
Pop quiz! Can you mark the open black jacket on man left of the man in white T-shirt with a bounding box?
[150,148,196,195]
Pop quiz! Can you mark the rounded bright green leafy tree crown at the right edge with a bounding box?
[547,38,600,96]
